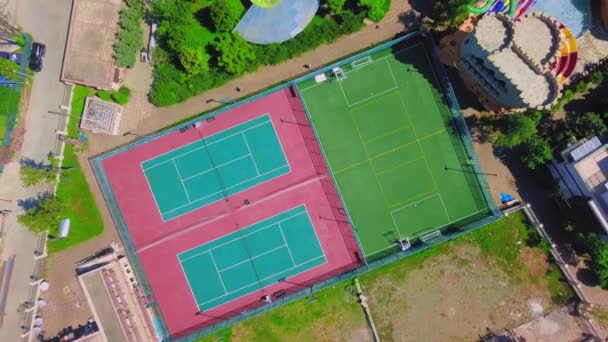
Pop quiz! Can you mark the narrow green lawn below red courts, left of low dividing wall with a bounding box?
[198,281,367,341]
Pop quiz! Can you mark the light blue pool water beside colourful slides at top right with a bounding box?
[528,0,591,38]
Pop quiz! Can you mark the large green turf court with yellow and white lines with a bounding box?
[298,44,488,258]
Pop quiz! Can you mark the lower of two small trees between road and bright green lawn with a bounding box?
[17,197,65,233]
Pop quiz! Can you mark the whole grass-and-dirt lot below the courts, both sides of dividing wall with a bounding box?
[200,213,573,341]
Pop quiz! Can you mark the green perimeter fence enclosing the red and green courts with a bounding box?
[90,32,501,341]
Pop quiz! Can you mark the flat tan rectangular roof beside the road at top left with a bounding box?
[61,0,122,89]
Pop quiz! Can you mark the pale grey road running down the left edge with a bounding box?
[0,0,72,341]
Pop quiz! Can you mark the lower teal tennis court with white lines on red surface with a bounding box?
[178,205,326,311]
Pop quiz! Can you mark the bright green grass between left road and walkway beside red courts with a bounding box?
[48,86,103,252]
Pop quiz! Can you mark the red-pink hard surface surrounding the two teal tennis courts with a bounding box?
[102,89,360,336]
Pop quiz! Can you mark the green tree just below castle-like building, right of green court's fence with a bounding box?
[496,112,542,148]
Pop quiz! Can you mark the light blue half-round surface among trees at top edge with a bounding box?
[234,0,319,44]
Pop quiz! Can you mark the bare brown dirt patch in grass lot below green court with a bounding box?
[364,244,553,341]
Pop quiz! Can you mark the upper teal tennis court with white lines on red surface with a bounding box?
[141,114,290,221]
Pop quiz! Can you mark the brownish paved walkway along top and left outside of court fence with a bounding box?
[45,0,420,334]
